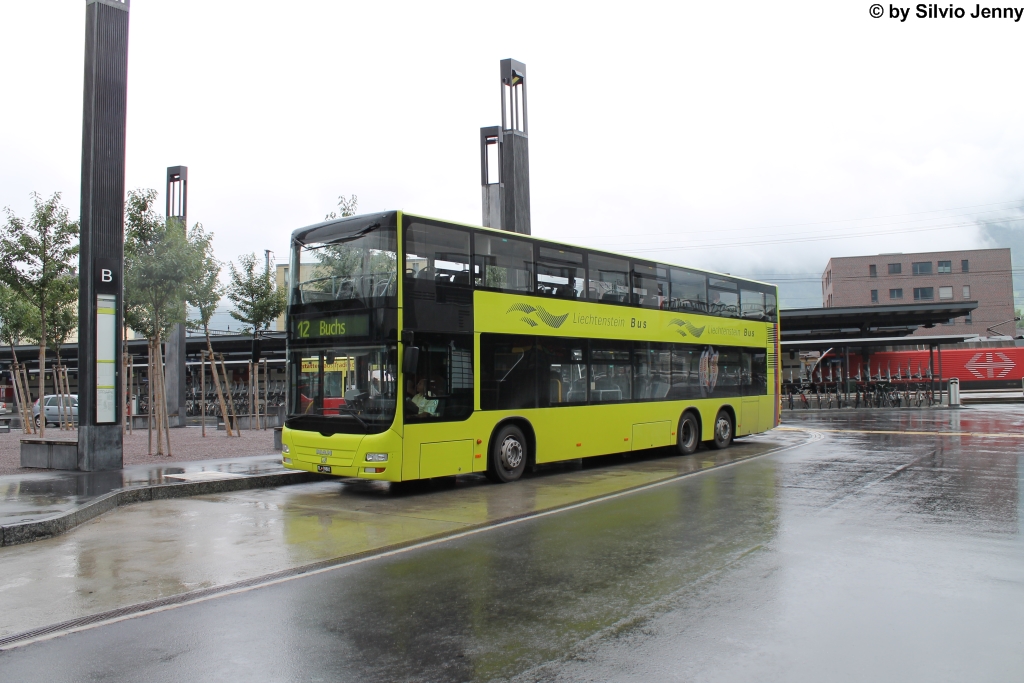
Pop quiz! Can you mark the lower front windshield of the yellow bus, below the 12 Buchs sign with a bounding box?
[288,344,397,434]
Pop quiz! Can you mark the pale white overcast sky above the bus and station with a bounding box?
[0,0,1024,307]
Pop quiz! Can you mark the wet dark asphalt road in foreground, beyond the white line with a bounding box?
[0,407,1024,682]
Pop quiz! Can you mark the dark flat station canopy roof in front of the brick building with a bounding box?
[779,301,978,346]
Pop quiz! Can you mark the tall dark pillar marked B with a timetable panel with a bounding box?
[78,0,129,471]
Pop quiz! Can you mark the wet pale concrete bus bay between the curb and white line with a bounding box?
[0,432,807,637]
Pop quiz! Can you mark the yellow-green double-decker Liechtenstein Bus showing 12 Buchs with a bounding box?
[282,211,779,482]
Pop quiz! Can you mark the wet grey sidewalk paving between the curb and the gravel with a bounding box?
[0,456,284,524]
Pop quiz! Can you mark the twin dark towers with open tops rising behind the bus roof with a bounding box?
[480,59,530,234]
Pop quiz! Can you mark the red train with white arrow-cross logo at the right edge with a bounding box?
[839,346,1024,389]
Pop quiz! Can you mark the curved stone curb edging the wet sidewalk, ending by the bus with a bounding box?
[0,472,326,547]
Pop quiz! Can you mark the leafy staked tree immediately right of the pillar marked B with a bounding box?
[124,189,203,455]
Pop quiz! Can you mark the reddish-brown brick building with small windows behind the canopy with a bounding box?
[821,249,1015,337]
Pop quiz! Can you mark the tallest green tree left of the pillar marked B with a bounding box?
[0,193,79,435]
